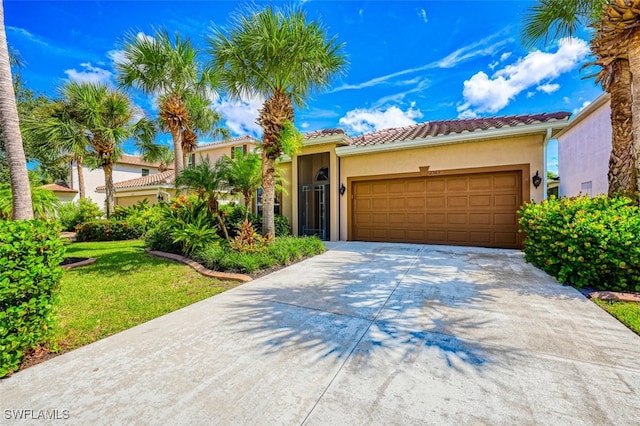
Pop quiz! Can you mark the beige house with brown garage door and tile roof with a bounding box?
[280,112,570,248]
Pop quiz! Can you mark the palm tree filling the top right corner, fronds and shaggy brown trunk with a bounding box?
[523,0,640,196]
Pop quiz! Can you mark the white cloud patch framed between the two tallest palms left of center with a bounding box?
[214,96,264,137]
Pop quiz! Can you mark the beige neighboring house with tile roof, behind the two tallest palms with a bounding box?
[102,136,258,207]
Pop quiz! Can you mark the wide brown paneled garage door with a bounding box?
[352,171,522,248]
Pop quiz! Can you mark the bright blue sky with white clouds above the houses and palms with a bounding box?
[4,0,602,172]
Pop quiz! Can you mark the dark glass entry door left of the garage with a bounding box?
[298,183,329,241]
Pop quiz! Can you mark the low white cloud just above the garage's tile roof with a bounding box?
[340,103,422,134]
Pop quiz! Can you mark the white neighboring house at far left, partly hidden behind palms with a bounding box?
[70,154,166,209]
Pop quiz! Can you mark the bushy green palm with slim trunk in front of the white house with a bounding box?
[30,81,158,216]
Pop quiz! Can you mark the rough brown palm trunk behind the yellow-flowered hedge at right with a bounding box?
[609,59,636,196]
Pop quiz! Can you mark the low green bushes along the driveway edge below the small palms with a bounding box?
[194,237,325,274]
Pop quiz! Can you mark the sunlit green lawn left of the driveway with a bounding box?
[52,241,238,350]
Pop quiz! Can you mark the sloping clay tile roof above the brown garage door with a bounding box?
[352,112,571,146]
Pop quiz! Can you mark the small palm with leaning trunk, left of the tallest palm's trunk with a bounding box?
[175,158,229,240]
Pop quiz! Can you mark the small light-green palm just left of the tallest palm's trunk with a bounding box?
[218,152,262,220]
